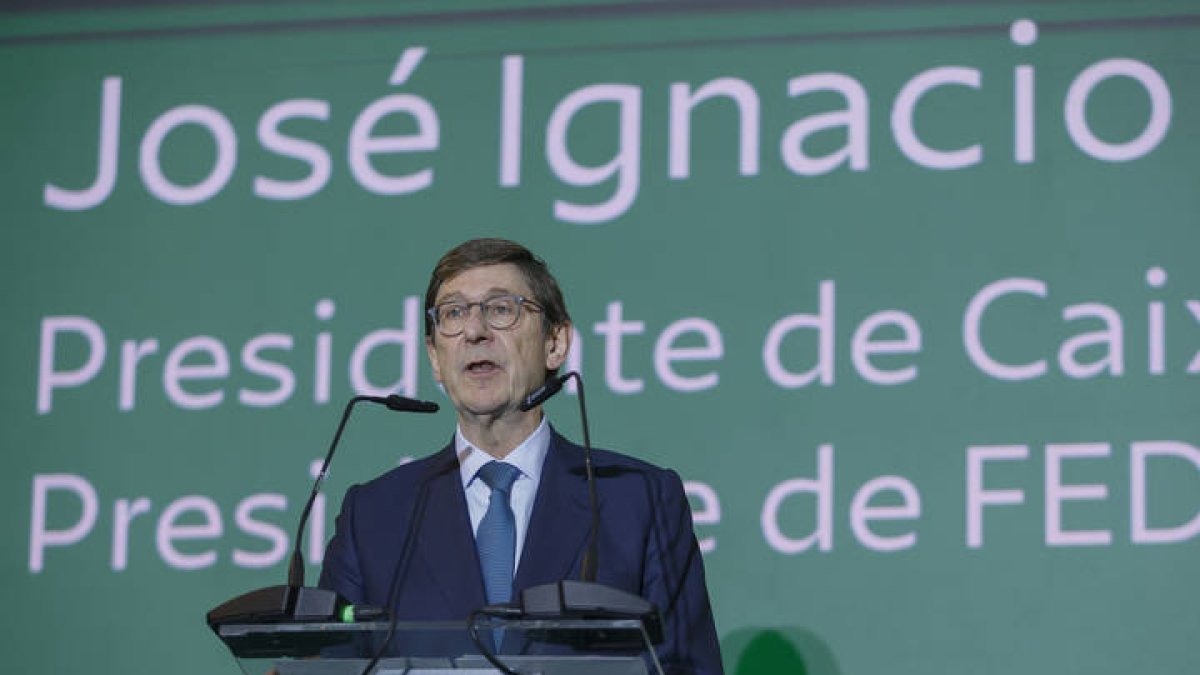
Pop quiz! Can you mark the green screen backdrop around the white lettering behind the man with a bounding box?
[0,1,1200,675]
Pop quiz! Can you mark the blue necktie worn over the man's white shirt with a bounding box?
[475,461,521,604]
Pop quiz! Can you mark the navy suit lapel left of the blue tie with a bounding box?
[416,444,487,616]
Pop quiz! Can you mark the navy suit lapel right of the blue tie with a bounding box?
[513,434,592,592]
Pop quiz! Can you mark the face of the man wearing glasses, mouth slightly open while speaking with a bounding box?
[425,263,570,418]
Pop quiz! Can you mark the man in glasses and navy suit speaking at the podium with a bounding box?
[320,239,721,675]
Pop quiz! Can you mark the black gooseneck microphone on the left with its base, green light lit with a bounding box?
[205,394,438,657]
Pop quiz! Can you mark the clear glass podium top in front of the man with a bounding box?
[217,619,662,675]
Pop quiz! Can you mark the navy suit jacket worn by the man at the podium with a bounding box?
[320,432,722,675]
